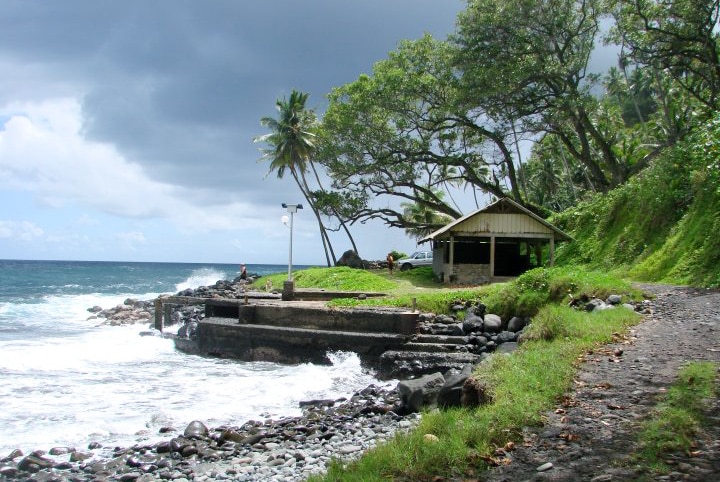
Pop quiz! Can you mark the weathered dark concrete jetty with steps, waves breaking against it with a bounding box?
[166,292,476,378]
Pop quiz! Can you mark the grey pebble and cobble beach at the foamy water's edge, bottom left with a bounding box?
[0,386,419,482]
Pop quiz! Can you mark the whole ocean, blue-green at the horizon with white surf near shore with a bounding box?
[0,260,391,458]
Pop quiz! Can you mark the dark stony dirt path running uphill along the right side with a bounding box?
[482,285,720,482]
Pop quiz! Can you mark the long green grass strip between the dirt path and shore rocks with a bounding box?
[309,306,639,482]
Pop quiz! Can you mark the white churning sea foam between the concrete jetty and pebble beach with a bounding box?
[0,292,394,455]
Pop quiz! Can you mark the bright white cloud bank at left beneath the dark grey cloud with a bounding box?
[0,98,255,229]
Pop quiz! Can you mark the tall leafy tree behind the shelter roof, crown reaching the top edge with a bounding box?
[454,0,632,190]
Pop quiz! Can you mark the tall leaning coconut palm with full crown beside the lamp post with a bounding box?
[254,90,336,266]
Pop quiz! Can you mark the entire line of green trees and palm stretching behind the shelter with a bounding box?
[256,0,720,265]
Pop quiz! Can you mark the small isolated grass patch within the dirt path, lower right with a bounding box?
[636,362,718,473]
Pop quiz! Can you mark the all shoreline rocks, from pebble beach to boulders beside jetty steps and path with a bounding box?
[0,279,640,482]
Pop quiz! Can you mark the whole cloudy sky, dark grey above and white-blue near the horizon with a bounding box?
[0,0,464,264]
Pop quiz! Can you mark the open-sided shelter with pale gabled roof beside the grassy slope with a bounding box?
[419,198,572,284]
